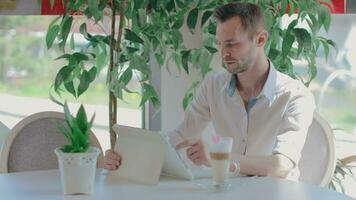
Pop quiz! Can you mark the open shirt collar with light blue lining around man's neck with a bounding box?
[226,60,277,104]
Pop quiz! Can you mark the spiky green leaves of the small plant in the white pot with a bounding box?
[58,102,95,153]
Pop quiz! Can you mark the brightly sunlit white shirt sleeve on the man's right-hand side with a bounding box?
[273,88,315,166]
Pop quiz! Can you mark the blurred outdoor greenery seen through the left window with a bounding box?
[0,16,140,109]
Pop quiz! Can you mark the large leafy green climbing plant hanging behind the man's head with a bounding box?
[47,0,335,125]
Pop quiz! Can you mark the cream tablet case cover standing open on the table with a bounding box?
[110,124,166,185]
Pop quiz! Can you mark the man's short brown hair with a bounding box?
[214,2,264,32]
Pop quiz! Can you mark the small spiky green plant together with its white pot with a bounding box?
[54,102,100,194]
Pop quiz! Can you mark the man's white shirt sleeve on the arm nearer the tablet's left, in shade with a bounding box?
[169,74,212,145]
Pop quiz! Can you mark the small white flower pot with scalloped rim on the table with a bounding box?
[54,147,100,195]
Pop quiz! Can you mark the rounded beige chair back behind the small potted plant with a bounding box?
[0,111,103,173]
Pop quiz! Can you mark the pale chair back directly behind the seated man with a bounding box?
[298,112,336,186]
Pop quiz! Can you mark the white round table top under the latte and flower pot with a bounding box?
[0,170,351,200]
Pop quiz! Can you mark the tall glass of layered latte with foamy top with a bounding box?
[209,137,233,187]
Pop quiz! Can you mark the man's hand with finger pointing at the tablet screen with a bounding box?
[176,140,210,167]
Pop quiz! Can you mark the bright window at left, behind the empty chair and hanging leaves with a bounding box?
[0,16,143,150]
